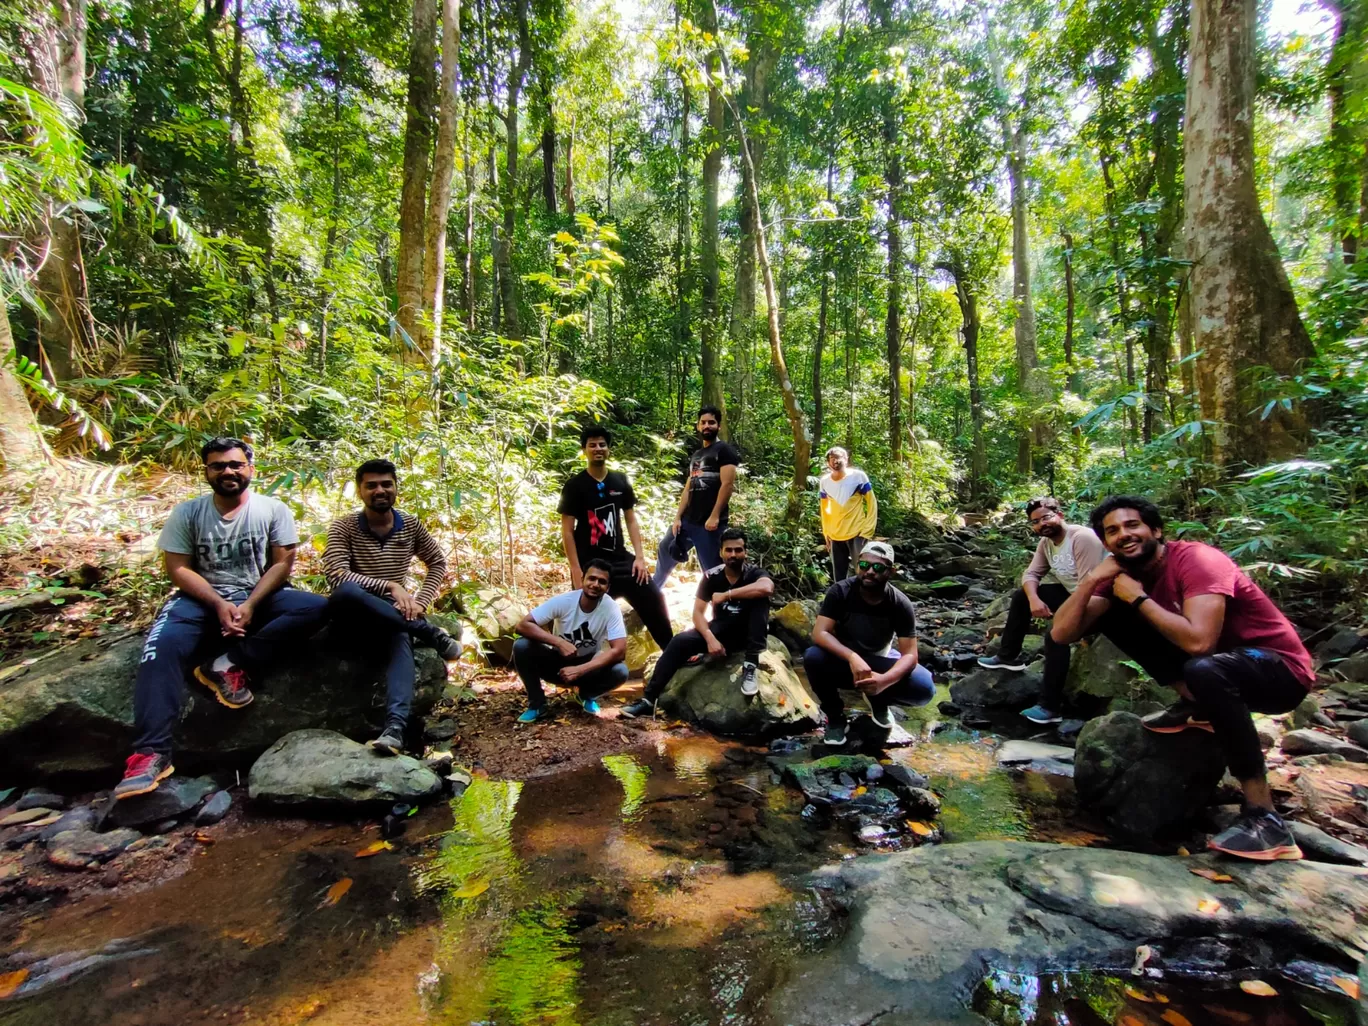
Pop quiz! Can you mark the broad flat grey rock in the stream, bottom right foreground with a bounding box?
[769,841,1368,1026]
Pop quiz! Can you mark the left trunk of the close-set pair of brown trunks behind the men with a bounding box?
[395,0,436,347]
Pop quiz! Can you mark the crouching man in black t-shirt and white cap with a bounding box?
[803,542,936,746]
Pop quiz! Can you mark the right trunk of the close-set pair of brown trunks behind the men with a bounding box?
[423,0,461,367]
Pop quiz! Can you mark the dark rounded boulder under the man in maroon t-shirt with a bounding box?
[1074,713,1226,843]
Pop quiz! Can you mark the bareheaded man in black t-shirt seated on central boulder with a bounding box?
[622,527,774,718]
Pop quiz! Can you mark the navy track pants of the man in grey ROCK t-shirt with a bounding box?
[133,588,328,755]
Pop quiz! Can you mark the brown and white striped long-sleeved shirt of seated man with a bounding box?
[323,510,446,609]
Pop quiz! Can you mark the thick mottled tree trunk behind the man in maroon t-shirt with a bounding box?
[1183,0,1312,466]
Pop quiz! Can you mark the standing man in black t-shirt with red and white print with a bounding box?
[560,424,674,648]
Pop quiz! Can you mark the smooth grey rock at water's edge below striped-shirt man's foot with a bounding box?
[248,731,442,807]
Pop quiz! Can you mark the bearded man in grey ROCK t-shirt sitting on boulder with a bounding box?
[114,438,327,799]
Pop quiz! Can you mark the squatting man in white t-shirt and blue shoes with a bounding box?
[513,558,627,724]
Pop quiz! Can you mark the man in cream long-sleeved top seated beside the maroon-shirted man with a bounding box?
[978,495,1107,724]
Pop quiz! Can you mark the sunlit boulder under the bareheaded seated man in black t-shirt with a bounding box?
[659,635,818,737]
